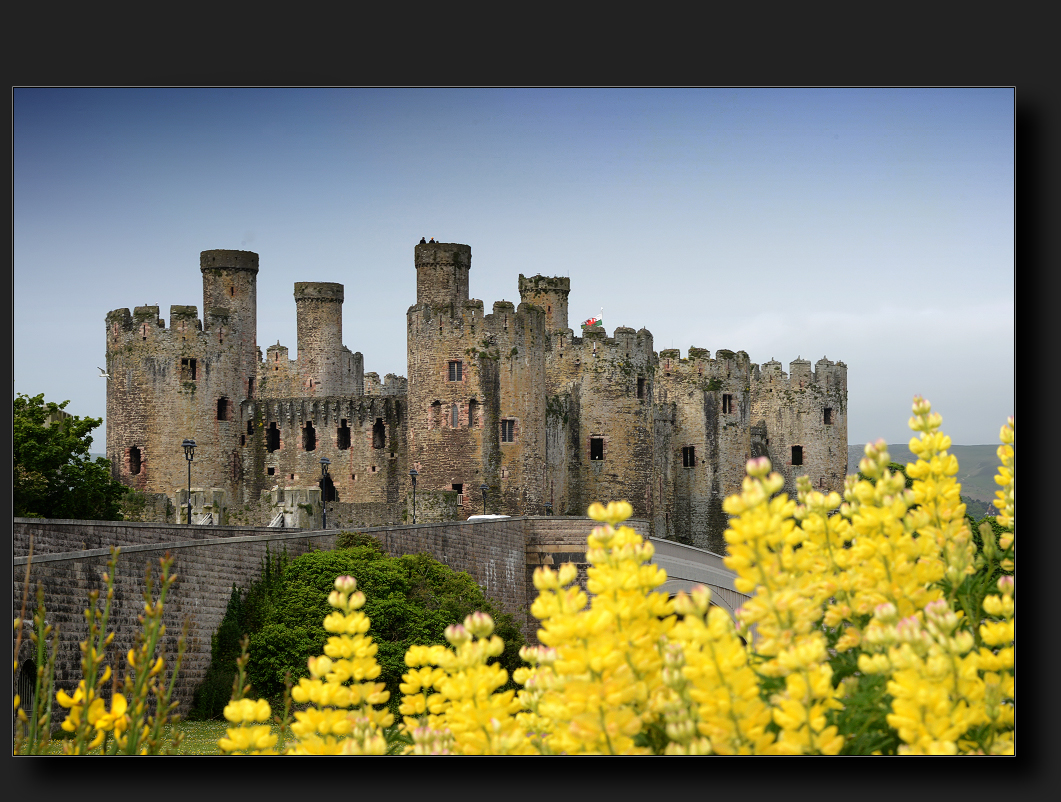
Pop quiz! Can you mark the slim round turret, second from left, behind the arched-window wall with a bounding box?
[295,281,345,396]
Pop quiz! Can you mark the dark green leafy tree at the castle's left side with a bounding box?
[13,393,128,521]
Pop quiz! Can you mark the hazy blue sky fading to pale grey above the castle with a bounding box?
[13,89,1013,453]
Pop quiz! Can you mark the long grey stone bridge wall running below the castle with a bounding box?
[13,518,646,715]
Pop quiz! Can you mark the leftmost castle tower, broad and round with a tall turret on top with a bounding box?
[107,250,258,517]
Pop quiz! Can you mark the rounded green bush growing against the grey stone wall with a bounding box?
[191,531,523,718]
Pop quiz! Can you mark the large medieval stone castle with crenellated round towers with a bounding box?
[106,241,847,553]
